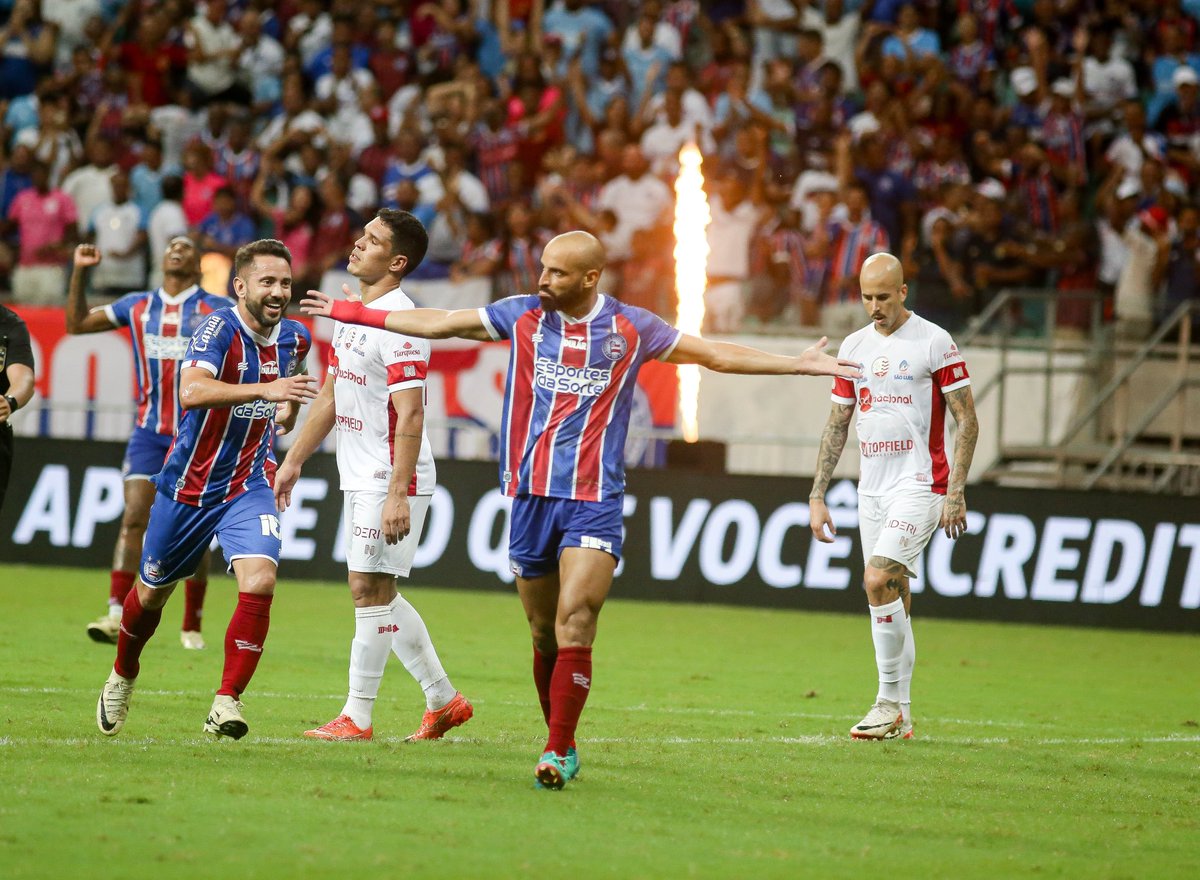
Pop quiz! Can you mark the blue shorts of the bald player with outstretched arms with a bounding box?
[509,495,625,577]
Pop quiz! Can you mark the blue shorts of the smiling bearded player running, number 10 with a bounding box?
[142,486,280,587]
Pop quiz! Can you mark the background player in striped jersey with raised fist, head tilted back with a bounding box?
[66,235,233,649]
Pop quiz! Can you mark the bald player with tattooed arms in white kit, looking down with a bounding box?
[809,253,979,740]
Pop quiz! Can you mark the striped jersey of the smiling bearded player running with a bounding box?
[155,307,312,507]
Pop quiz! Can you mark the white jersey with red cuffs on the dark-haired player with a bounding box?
[329,287,437,495]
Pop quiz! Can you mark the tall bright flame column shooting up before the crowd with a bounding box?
[674,144,712,443]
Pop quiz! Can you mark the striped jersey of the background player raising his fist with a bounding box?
[104,285,229,435]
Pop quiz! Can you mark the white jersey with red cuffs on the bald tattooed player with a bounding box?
[833,315,971,496]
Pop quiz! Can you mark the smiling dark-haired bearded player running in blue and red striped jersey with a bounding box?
[96,239,317,740]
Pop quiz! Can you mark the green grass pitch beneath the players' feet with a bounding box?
[0,565,1200,880]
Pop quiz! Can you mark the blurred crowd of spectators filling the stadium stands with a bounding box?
[0,0,1200,335]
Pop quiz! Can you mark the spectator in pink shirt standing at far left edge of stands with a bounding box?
[6,160,78,305]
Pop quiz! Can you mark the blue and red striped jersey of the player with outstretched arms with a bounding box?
[479,295,680,501]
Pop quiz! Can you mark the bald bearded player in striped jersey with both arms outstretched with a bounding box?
[301,232,859,789]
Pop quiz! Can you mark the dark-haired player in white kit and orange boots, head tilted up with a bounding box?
[275,209,473,742]
